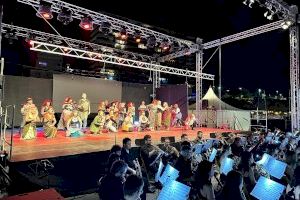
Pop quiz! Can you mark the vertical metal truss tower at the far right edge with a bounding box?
[290,26,300,131]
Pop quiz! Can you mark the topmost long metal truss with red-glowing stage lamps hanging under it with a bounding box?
[18,0,198,48]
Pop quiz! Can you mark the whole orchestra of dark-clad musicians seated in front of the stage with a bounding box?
[99,129,300,200]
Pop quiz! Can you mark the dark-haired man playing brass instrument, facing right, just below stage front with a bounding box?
[141,135,161,173]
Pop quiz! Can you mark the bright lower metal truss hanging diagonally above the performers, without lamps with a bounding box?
[30,40,214,80]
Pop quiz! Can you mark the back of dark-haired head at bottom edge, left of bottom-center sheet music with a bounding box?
[124,175,144,200]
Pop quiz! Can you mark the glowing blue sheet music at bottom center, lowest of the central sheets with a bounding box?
[158,180,191,200]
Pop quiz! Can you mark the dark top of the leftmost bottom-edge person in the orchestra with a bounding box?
[98,174,124,200]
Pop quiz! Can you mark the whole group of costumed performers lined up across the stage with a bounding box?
[21,93,196,139]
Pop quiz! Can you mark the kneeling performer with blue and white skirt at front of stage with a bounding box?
[66,110,83,137]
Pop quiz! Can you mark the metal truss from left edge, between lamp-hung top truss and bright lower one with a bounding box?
[2,23,155,62]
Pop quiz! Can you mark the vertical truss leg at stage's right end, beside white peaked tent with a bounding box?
[195,50,203,126]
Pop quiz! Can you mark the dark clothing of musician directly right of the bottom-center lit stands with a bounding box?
[174,155,193,182]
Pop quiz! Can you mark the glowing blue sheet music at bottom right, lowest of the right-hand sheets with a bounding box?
[250,176,285,200]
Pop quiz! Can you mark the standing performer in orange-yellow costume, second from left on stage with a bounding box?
[41,99,57,138]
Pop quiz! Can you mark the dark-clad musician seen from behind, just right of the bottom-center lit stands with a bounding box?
[174,145,193,184]
